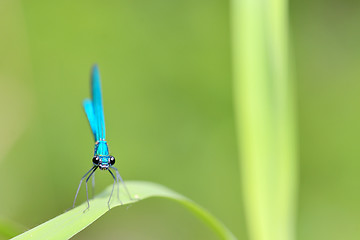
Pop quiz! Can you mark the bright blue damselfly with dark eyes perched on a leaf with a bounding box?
[73,65,132,210]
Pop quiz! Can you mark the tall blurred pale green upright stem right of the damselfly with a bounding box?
[231,0,297,240]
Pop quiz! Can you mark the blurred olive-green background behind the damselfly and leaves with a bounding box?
[0,0,360,240]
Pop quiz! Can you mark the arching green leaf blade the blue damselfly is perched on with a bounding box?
[13,181,236,240]
